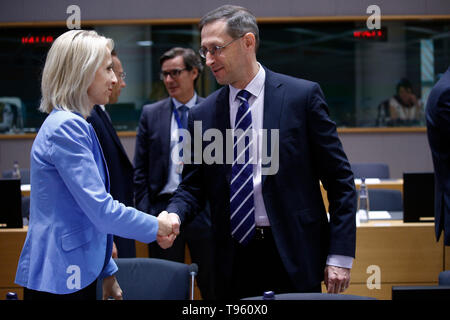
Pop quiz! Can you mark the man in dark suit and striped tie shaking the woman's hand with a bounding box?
[163,5,356,299]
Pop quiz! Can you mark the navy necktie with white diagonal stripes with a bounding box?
[230,90,255,245]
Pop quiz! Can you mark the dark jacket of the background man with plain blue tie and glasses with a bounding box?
[134,96,204,213]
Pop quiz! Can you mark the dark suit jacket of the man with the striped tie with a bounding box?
[168,69,356,298]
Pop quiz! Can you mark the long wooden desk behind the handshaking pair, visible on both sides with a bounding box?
[0,220,450,300]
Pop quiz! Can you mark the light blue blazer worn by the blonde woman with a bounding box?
[15,110,158,294]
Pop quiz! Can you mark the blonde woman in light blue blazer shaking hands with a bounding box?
[15,30,178,299]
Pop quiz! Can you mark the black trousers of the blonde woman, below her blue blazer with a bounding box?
[23,281,97,301]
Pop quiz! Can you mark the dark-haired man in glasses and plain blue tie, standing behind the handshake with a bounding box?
[134,48,214,300]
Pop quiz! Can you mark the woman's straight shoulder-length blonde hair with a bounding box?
[39,30,114,118]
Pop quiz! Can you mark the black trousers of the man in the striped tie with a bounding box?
[228,227,321,299]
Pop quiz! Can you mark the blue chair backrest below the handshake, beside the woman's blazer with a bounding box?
[97,258,196,300]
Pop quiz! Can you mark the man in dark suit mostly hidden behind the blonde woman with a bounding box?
[87,50,136,258]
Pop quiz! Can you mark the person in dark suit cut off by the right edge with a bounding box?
[426,68,450,246]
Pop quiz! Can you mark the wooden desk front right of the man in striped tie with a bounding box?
[346,220,442,300]
